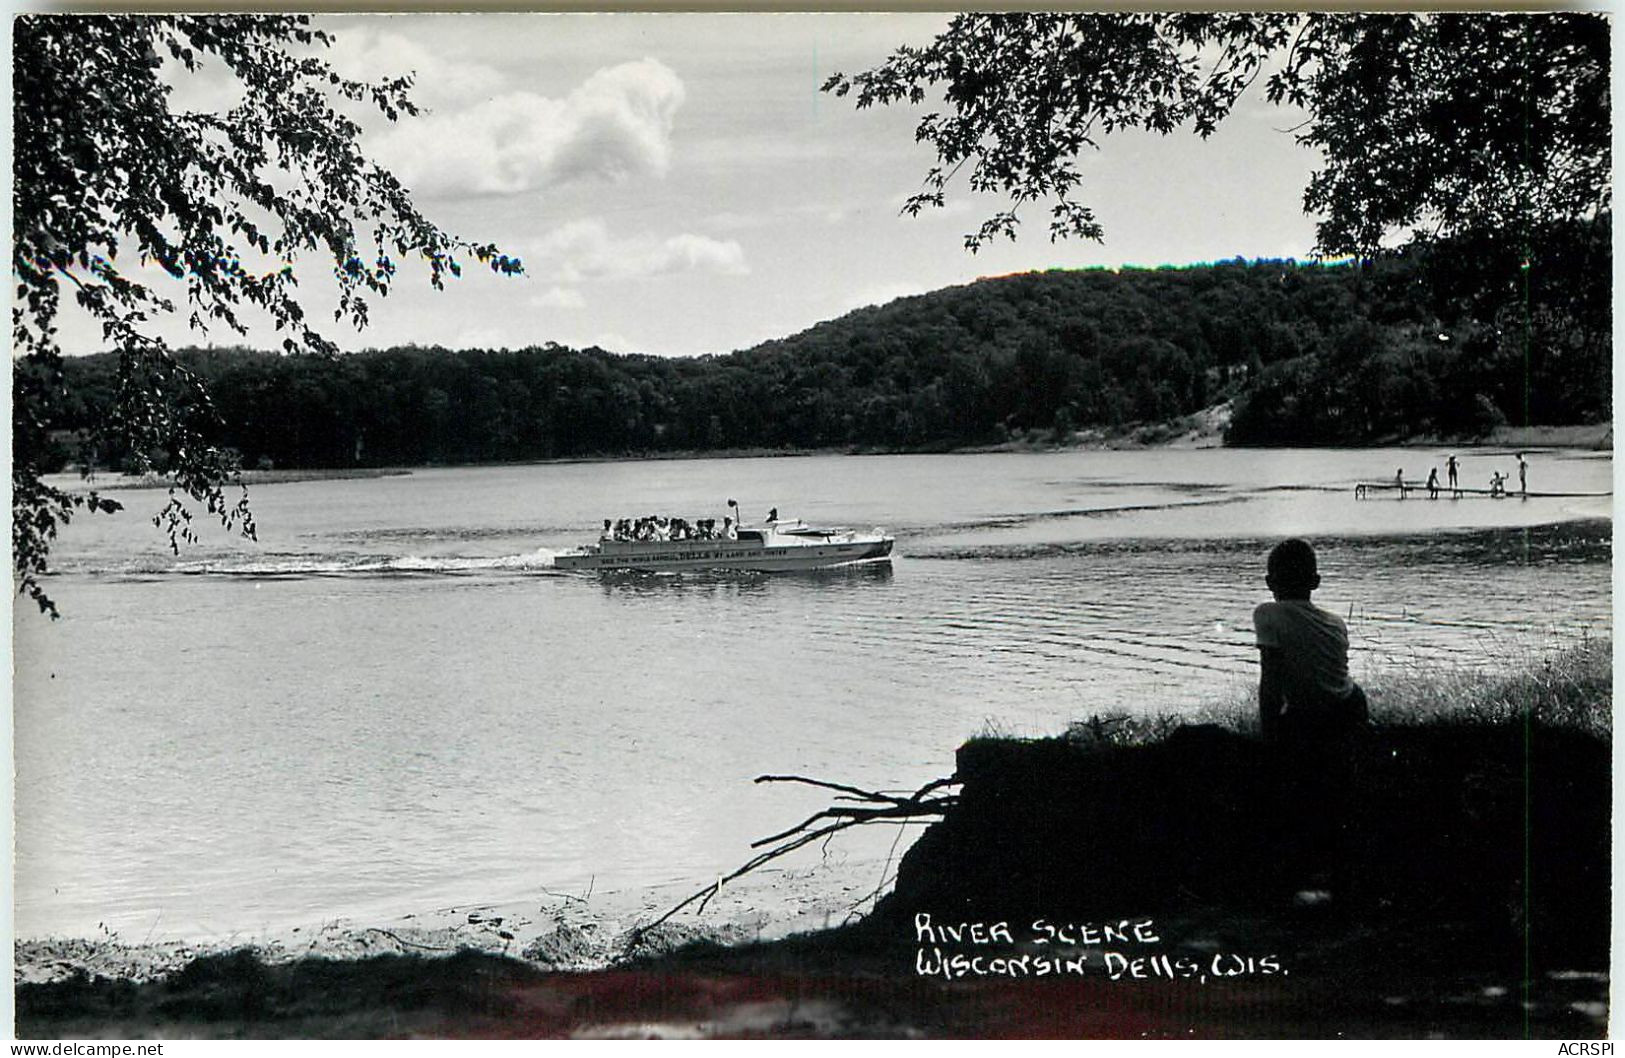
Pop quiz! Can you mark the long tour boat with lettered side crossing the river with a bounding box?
[553,520,894,572]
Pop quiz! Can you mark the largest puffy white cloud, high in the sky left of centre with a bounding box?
[371,59,684,195]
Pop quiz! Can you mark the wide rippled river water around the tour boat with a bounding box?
[15,449,1612,941]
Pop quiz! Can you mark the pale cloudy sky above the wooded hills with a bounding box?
[50,13,1316,356]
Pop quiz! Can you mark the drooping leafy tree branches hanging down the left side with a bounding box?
[11,15,522,616]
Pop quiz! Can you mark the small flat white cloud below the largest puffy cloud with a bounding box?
[527,219,751,283]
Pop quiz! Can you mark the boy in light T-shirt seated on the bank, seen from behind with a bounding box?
[1253,540,1368,741]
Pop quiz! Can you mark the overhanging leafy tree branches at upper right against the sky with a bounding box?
[824,11,1612,255]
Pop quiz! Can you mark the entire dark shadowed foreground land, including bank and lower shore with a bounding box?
[16,640,1612,1038]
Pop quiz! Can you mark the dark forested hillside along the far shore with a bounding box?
[41,219,1610,466]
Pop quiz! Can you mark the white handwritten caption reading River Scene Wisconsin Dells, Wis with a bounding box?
[913,912,1287,985]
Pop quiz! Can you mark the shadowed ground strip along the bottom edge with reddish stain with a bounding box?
[18,910,1607,1038]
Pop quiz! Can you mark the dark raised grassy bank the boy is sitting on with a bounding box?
[873,639,1612,1035]
